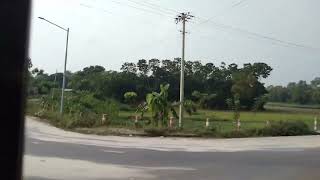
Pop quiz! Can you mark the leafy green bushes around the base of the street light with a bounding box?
[34,91,119,128]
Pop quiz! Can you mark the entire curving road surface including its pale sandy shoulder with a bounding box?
[24,118,320,180]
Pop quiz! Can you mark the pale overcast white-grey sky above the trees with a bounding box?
[30,0,320,84]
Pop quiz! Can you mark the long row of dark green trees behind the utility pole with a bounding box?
[28,58,272,110]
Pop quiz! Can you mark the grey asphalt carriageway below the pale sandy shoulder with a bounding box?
[24,117,320,180]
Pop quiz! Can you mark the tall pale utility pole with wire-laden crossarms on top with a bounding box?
[175,12,194,128]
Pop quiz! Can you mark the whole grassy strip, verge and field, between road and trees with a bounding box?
[26,100,317,138]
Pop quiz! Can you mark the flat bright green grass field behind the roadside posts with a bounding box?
[27,101,320,133]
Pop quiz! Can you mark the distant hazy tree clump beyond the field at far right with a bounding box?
[268,77,320,104]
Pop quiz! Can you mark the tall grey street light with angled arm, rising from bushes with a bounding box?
[38,17,69,115]
